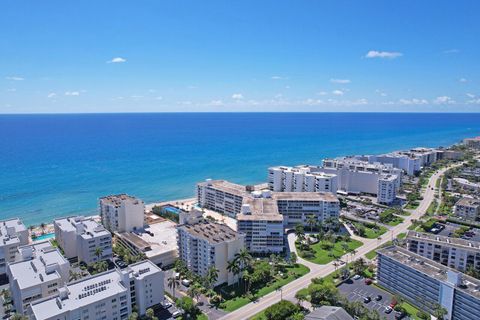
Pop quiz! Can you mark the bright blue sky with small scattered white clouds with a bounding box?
[0,0,480,113]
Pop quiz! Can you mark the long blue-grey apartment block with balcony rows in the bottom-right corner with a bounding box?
[377,246,480,320]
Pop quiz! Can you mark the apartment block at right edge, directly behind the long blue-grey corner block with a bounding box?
[406,231,480,272]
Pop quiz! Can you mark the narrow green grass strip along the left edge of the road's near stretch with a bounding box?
[220,263,310,312]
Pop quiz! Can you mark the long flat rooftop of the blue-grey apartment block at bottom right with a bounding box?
[377,246,480,299]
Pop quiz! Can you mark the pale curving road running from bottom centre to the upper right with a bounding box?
[220,164,461,320]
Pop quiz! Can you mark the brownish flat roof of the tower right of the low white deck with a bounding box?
[178,220,239,244]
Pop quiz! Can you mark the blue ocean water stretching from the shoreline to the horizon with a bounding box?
[0,113,480,224]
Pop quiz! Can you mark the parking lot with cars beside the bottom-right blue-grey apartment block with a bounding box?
[338,277,405,320]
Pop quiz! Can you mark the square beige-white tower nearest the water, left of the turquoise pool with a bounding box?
[100,194,145,232]
